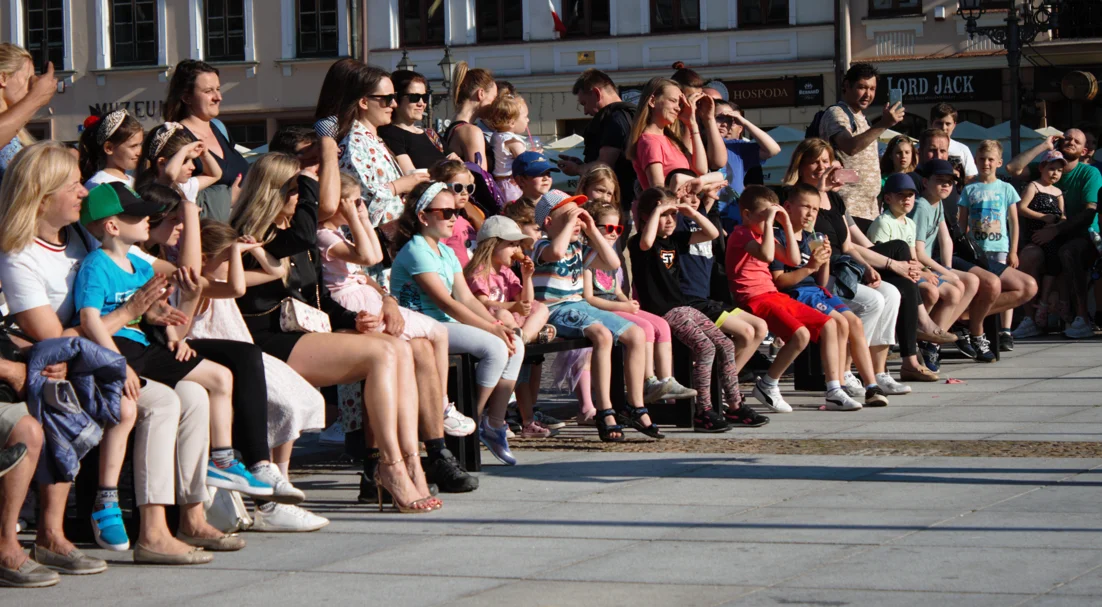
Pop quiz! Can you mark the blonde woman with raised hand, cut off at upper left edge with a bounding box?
[0,42,57,180]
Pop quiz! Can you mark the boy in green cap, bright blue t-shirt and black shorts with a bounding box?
[73,183,273,508]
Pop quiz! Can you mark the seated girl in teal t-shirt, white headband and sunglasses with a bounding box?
[390,182,525,466]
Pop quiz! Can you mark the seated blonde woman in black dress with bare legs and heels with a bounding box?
[230,145,443,513]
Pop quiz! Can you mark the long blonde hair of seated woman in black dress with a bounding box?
[229,152,300,242]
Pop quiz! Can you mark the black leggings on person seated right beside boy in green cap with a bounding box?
[187,339,271,467]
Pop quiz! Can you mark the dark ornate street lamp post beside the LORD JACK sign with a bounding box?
[957,0,1063,156]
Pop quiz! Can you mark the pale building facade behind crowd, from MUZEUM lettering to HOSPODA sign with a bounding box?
[0,0,838,147]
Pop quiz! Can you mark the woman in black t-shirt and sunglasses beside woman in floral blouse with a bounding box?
[379,69,445,174]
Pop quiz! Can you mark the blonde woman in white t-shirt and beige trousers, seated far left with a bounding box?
[0,141,220,574]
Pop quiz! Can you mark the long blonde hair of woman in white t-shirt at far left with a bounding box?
[0,140,77,253]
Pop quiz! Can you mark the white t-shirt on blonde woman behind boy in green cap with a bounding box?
[0,226,91,327]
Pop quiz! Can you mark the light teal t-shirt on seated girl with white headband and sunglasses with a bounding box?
[390,234,463,323]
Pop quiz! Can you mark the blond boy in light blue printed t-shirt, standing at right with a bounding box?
[957,139,1022,334]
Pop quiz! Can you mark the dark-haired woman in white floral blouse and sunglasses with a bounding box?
[337,64,429,227]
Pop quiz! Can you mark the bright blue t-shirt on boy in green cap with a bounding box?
[73,249,153,346]
